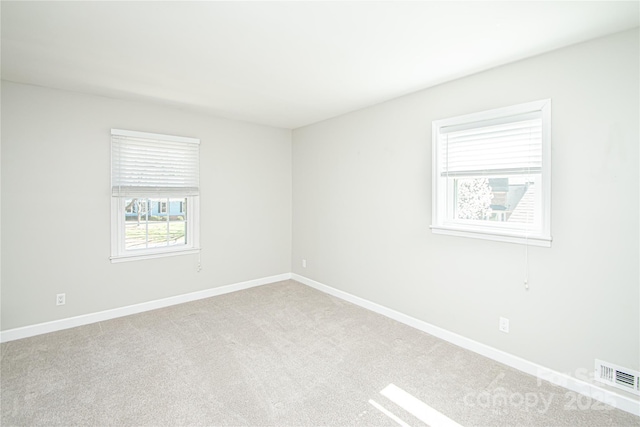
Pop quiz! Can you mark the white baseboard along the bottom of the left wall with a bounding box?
[0,273,291,342]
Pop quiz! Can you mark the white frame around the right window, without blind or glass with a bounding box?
[430,99,552,247]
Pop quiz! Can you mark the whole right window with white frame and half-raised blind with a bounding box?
[431,99,551,247]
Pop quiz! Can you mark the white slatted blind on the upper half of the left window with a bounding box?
[111,129,200,197]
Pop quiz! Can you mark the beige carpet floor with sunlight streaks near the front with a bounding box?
[0,281,640,427]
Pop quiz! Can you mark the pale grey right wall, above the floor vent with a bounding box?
[292,30,640,375]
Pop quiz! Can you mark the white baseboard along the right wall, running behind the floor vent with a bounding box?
[291,273,640,416]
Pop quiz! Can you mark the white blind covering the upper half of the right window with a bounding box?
[438,112,542,177]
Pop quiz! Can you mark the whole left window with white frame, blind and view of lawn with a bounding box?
[111,129,200,262]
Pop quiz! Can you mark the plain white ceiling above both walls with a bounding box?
[1,1,640,128]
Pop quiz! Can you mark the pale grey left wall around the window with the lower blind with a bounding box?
[2,82,291,330]
